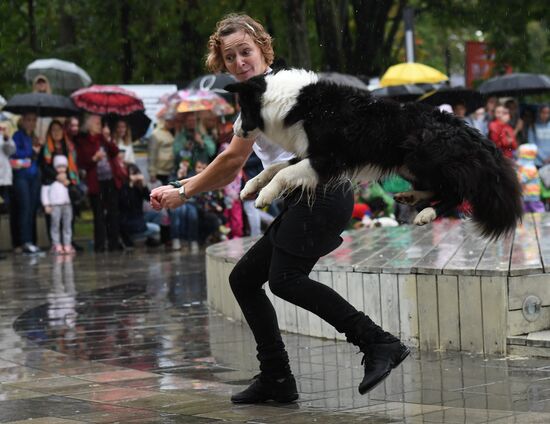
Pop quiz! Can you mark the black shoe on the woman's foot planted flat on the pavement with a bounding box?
[231,374,298,403]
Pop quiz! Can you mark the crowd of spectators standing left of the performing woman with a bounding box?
[0,85,274,255]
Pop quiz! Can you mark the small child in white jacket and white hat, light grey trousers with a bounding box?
[41,155,74,255]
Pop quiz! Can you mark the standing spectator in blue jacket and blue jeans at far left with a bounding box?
[10,113,41,254]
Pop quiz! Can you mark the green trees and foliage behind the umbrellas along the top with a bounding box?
[0,0,550,97]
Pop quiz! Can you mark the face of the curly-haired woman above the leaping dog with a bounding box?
[221,31,267,81]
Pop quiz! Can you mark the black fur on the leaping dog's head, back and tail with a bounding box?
[228,72,523,238]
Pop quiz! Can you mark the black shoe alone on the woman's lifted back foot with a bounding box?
[359,340,411,395]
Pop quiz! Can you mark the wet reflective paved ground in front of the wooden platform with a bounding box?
[0,251,550,424]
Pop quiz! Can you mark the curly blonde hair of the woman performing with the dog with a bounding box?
[205,13,275,73]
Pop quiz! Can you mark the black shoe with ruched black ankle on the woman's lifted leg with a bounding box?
[346,315,410,395]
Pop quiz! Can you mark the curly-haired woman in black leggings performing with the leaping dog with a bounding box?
[151,15,409,403]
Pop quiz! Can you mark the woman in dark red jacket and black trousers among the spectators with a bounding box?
[76,115,124,252]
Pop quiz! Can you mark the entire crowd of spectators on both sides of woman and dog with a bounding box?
[0,78,550,254]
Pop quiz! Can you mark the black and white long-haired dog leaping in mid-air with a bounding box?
[225,69,522,238]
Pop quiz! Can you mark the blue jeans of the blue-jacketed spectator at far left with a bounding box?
[13,172,40,244]
